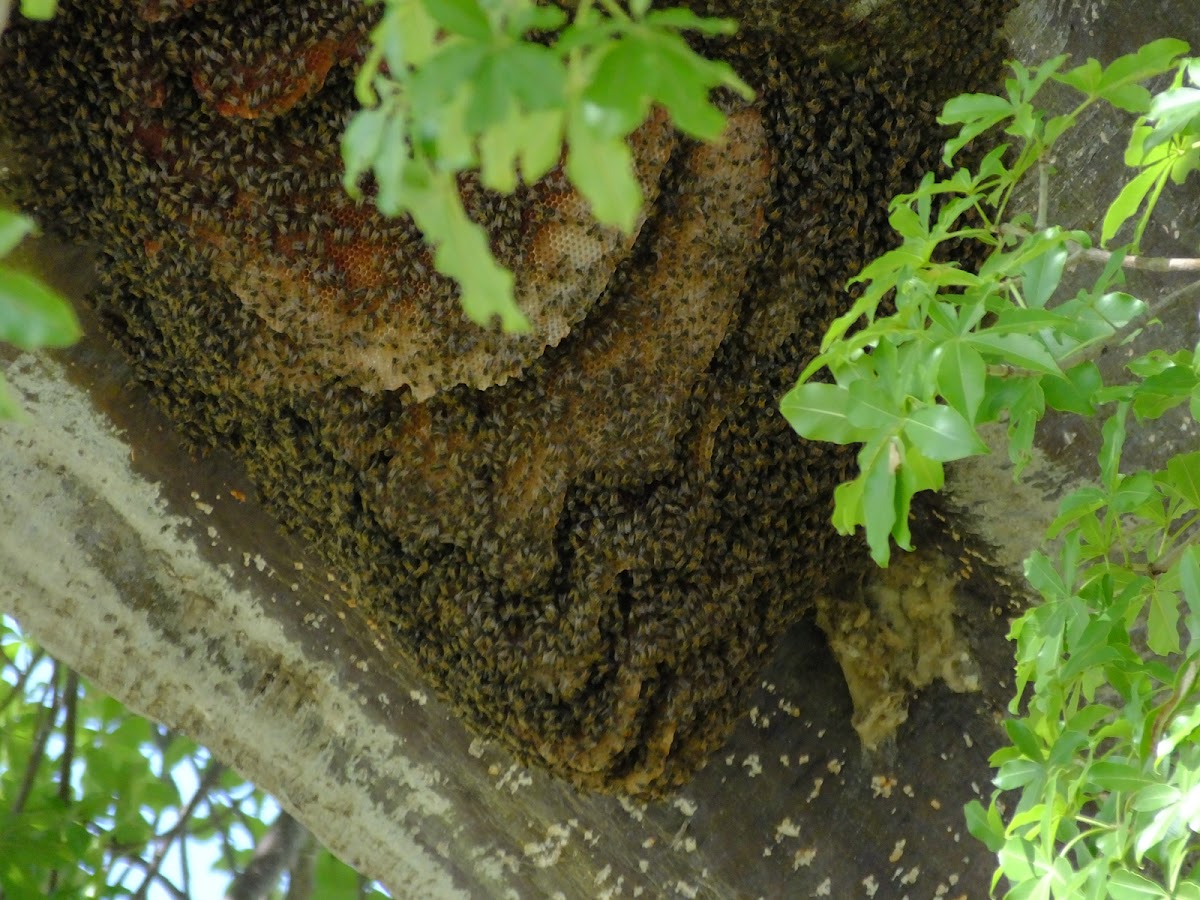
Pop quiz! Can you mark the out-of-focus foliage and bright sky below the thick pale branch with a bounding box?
[0,618,379,900]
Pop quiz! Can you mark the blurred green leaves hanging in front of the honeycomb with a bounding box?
[342,0,751,330]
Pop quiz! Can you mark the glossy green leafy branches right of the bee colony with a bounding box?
[781,40,1200,900]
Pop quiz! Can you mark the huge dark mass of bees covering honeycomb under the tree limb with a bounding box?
[0,0,1008,796]
